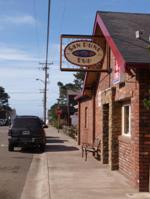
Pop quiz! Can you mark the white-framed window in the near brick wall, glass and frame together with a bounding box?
[122,104,131,136]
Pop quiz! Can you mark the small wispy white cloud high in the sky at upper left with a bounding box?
[0,15,36,25]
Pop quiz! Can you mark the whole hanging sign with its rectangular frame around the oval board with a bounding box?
[60,34,110,73]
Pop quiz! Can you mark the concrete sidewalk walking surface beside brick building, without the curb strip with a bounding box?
[46,127,150,199]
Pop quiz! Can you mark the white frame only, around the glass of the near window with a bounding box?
[122,104,131,137]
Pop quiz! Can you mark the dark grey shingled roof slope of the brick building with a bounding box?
[97,11,150,64]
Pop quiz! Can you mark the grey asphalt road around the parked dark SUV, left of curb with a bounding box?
[0,127,33,199]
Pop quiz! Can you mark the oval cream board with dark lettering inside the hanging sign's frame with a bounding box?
[64,40,104,67]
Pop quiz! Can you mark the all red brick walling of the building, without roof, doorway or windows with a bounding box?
[80,37,150,191]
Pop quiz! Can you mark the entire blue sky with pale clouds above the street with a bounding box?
[0,0,150,116]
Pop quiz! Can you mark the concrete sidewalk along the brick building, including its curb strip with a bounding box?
[21,127,150,199]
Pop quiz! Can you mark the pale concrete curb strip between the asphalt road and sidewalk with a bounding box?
[20,153,50,199]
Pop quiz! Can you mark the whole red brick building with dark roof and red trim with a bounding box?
[78,11,150,191]
